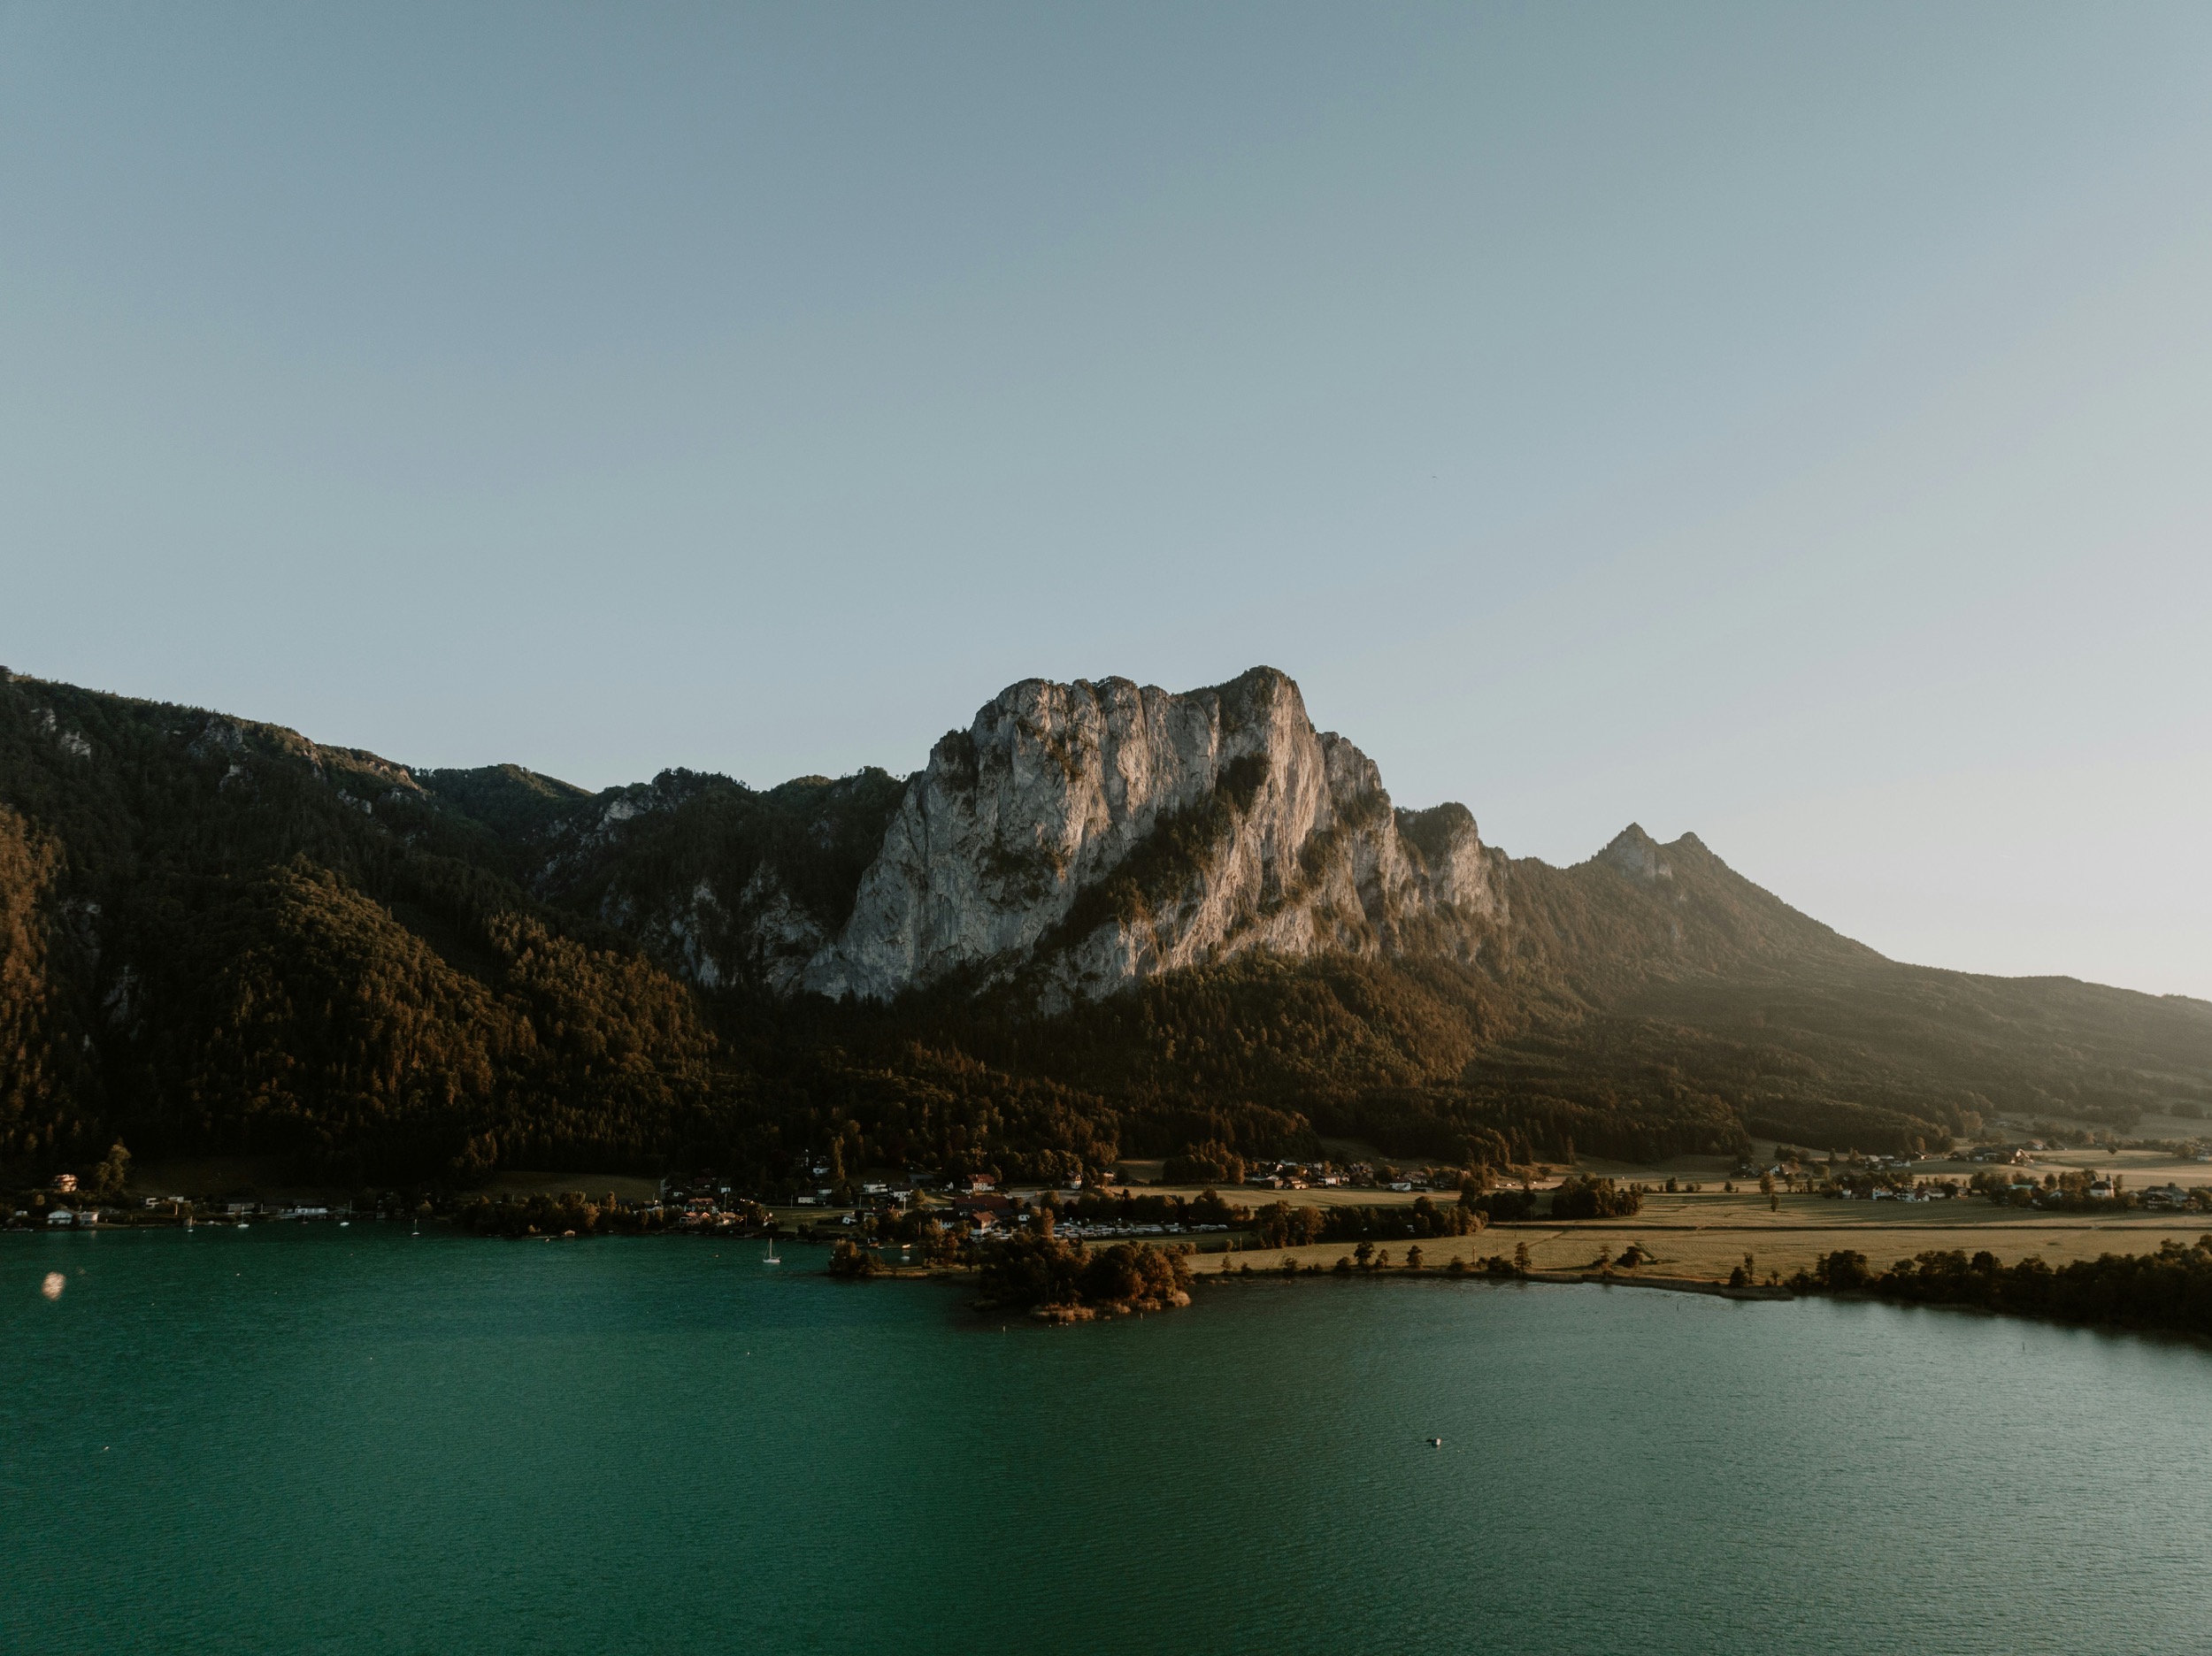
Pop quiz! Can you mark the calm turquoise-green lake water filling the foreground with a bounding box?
[0,1225,2212,1656]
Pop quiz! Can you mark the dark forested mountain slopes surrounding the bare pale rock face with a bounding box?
[0,677,2212,1190]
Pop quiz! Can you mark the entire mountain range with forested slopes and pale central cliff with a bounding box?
[0,668,2212,1183]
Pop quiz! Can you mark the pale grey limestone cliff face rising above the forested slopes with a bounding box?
[786,668,1504,1004]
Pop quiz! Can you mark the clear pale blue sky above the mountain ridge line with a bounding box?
[0,0,2212,997]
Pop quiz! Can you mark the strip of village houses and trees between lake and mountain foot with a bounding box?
[17,1128,2212,1238]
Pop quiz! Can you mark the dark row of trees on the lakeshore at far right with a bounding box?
[1790,1234,2212,1336]
